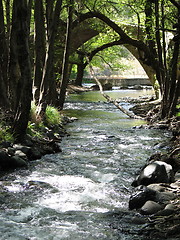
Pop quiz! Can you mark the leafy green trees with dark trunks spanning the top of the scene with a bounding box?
[0,0,180,140]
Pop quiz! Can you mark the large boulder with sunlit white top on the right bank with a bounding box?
[132,161,174,187]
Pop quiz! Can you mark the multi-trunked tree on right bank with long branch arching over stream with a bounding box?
[72,0,180,118]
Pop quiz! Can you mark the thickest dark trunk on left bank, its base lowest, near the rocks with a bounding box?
[11,0,32,141]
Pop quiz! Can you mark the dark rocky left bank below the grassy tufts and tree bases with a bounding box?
[0,115,74,176]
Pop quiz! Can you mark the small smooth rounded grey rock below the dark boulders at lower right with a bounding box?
[140,201,162,215]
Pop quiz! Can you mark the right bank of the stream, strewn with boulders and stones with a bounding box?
[129,103,180,239]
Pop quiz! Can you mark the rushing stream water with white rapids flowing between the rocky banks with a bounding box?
[0,90,174,240]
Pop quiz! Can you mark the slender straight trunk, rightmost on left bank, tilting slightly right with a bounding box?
[59,0,73,109]
